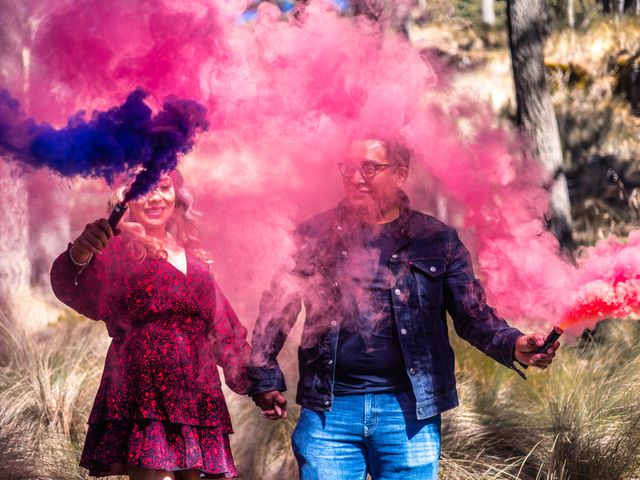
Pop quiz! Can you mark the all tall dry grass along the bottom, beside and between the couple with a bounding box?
[0,317,640,480]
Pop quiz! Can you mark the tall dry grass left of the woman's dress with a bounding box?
[0,319,107,480]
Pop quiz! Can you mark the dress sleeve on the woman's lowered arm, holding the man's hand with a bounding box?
[206,279,251,395]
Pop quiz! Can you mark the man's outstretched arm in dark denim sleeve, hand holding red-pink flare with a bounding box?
[444,230,559,368]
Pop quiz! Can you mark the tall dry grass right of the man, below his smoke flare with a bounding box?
[445,322,640,480]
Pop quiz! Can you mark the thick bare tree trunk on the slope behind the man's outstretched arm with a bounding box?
[507,0,573,247]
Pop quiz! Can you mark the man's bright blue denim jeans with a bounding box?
[293,391,440,480]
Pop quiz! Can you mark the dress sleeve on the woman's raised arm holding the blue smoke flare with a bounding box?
[51,242,121,320]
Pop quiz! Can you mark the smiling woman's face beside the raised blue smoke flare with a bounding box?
[129,175,176,231]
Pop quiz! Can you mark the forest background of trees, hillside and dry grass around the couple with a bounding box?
[0,0,640,480]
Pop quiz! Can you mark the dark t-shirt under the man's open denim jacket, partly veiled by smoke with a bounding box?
[333,220,411,395]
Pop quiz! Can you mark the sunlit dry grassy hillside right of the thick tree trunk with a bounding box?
[545,16,640,244]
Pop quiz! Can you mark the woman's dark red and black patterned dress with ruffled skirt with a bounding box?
[51,237,249,478]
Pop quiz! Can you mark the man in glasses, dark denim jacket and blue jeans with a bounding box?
[252,139,559,480]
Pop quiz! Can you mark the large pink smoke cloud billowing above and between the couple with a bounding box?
[0,0,640,333]
